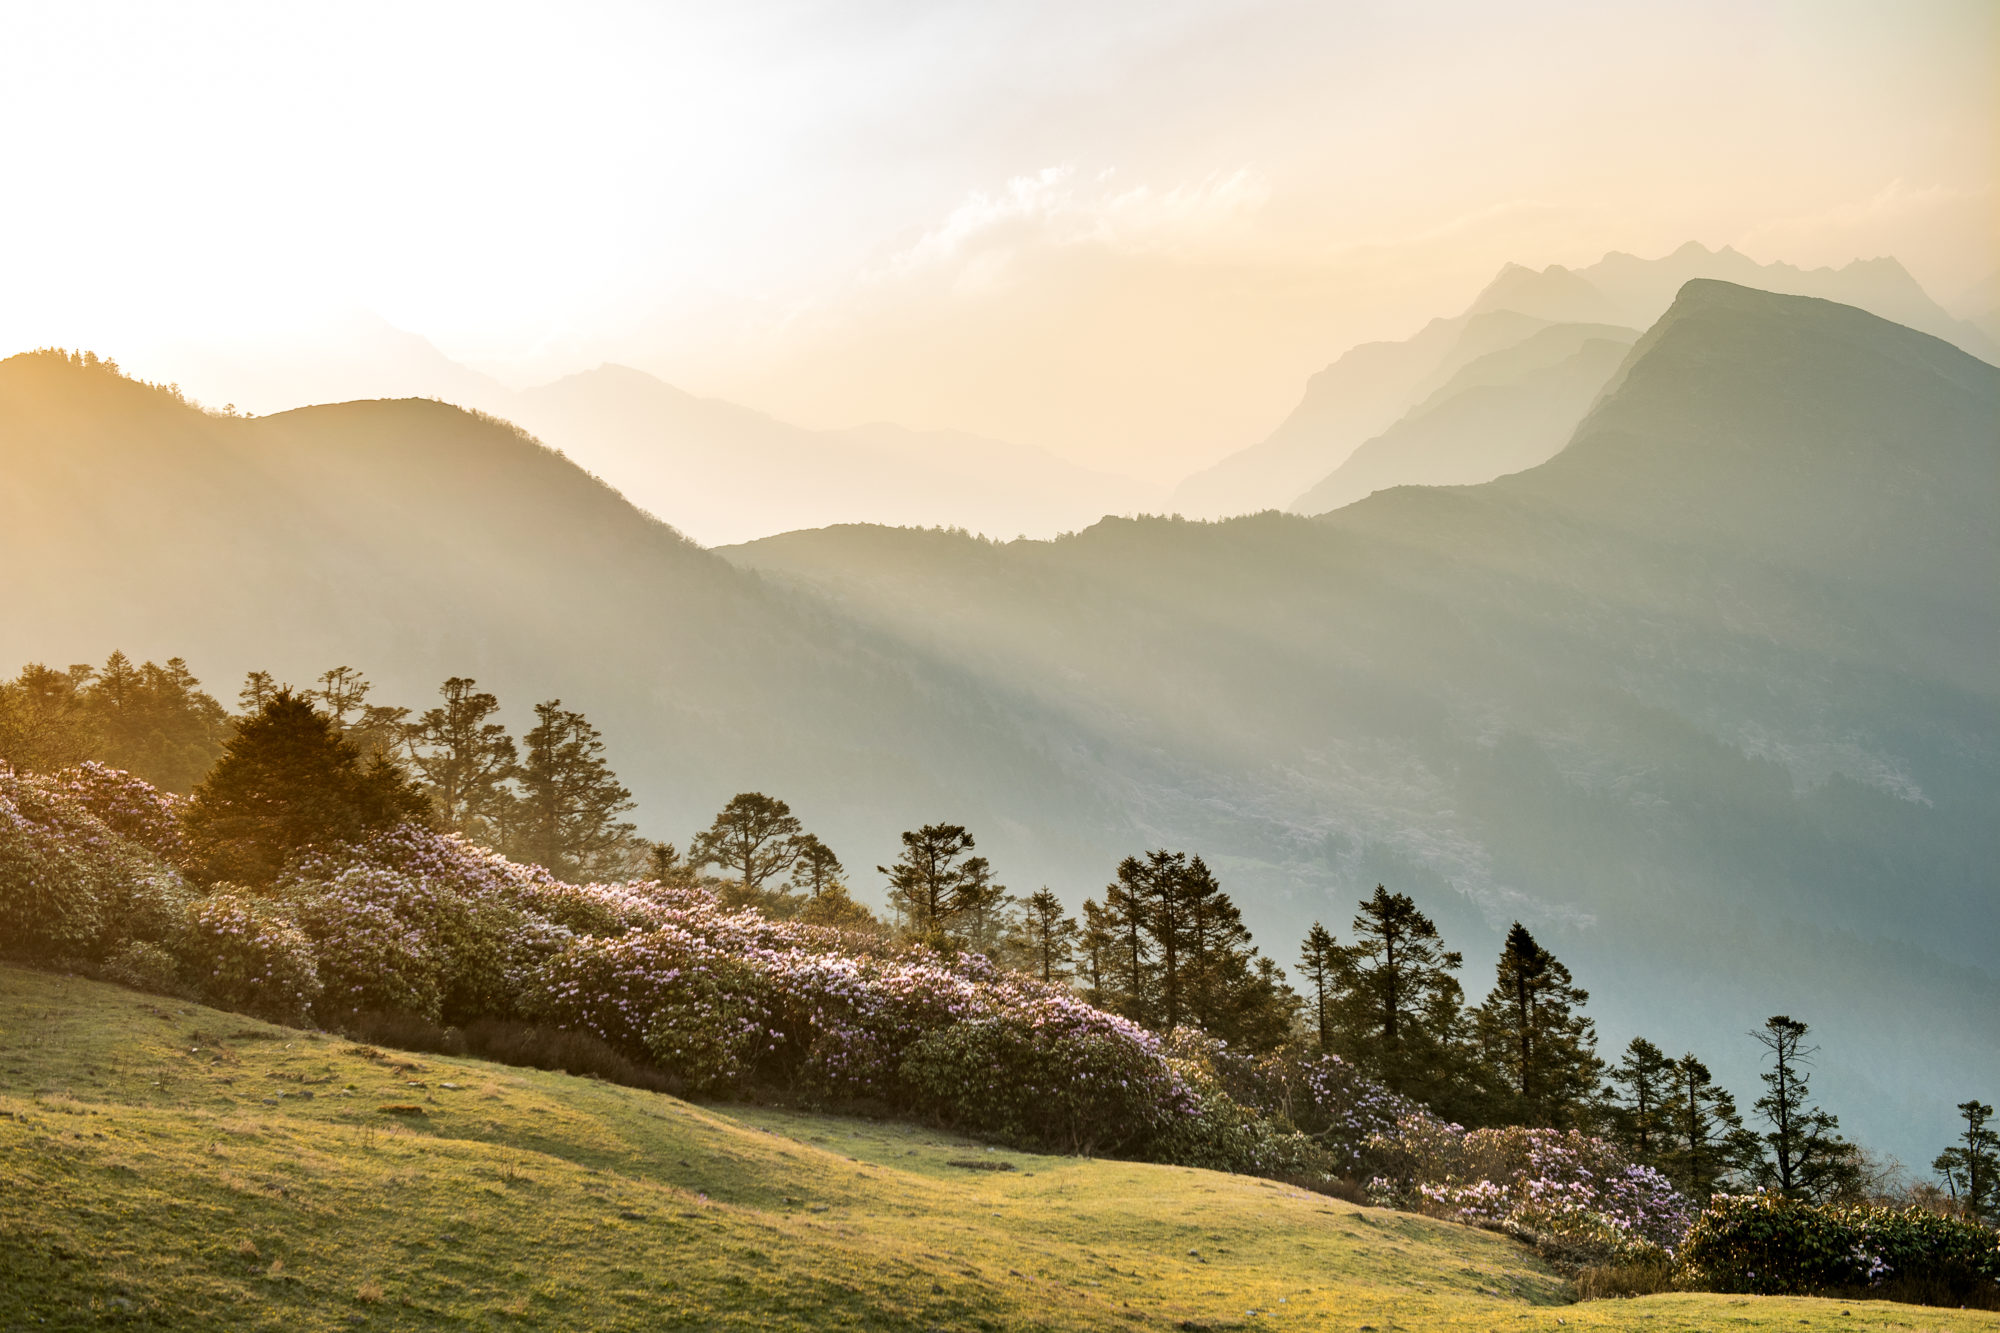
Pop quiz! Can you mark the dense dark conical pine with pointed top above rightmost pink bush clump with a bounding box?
[1472,921,1604,1129]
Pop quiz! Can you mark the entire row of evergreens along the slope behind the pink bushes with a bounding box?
[0,652,2000,1215]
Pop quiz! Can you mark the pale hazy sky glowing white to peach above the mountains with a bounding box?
[0,0,2000,478]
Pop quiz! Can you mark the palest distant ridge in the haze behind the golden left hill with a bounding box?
[137,322,1164,546]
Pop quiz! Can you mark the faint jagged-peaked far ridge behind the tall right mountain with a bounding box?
[1172,242,1996,518]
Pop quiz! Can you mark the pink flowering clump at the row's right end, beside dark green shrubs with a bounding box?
[1368,1113,1694,1263]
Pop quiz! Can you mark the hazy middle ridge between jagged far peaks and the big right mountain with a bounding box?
[1288,324,1638,514]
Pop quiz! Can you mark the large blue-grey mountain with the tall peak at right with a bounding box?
[732,282,2000,1155]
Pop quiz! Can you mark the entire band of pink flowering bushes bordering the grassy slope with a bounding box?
[0,765,1688,1253]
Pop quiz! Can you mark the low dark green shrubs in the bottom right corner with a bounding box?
[1680,1193,2000,1301]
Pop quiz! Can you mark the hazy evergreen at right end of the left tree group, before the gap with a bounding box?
[508,699,636,879]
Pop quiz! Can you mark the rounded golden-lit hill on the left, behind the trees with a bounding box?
[0,354,1144,872]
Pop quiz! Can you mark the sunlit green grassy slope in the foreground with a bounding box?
[0,967,2000,1333]
